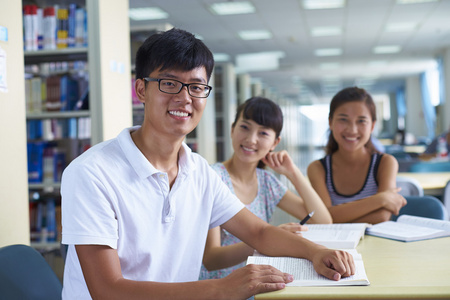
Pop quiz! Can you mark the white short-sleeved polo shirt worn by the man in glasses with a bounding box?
[61,127,244,299]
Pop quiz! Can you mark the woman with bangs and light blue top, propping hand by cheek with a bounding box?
[200,97,332,279]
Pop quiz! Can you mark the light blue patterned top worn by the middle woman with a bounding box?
[199,163,287,279]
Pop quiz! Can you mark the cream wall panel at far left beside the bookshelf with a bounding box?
[0,1,30,247]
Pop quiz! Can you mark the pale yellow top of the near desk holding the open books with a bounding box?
[255,236,450,300]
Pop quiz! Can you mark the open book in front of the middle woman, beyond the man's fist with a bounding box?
[301,223,370,249]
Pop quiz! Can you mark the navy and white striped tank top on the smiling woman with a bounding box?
[320,153,383,206]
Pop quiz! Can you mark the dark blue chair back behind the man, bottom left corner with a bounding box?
[0,245,62,300]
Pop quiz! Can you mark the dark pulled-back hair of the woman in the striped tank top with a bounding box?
[325,87,377,154]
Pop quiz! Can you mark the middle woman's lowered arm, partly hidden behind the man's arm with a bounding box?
[203,226,254,271]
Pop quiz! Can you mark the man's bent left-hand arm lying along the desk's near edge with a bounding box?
[75,245,292,300]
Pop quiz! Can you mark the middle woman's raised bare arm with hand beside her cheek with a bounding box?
[263,150,333,224]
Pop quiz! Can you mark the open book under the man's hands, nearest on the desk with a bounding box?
[247,249,370,286]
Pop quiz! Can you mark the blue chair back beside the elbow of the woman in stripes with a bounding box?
[392,195,448,221]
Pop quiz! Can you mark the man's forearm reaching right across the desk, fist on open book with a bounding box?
[222,208,355,280]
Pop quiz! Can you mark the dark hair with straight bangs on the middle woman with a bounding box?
[231,97,283,169]
